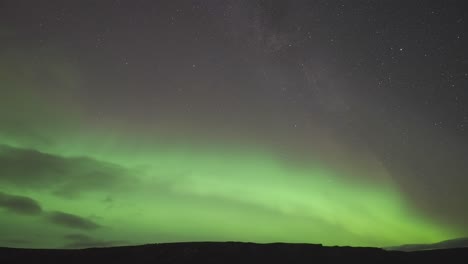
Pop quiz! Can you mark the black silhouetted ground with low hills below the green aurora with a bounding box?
[0,242,468,264]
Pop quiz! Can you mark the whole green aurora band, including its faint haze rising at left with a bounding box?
[0,53,459,248]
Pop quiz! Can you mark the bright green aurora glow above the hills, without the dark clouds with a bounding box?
[2,139,460,247]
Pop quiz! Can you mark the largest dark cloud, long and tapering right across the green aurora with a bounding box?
[0,145,137,197]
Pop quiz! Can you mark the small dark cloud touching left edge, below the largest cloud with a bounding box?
[0,192,42,215]
